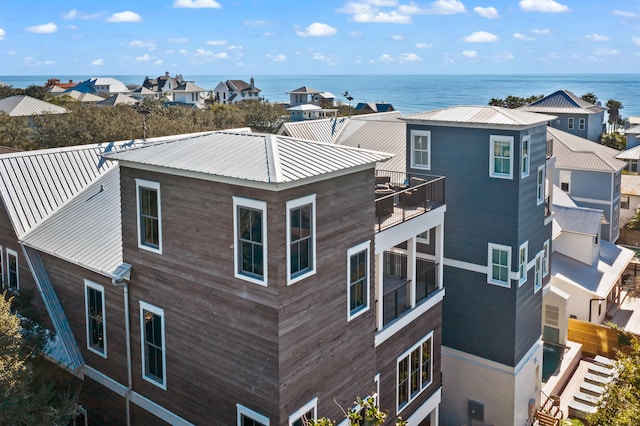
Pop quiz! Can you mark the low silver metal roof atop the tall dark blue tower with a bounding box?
[401,106,556,127]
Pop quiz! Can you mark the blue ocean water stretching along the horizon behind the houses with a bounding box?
[0,74,640,117]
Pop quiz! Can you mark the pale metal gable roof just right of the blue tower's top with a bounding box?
[547,127,627,172]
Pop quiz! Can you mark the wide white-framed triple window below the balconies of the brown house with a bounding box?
[397,332,433,413]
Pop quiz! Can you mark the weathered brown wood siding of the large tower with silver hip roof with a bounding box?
[121,167,375,425]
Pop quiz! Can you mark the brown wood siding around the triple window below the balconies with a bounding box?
[376,303,442,424]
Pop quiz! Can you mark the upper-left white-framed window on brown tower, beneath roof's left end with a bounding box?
[136,179,162,253]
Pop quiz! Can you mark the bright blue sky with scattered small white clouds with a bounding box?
[0,0,640,76]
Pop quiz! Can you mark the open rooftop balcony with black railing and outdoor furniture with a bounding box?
[375,170,445,232]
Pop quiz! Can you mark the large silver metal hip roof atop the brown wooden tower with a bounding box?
[105,132,391,183]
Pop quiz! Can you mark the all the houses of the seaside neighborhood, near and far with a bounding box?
[0,72,640,426]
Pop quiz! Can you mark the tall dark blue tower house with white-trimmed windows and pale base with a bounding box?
[403,106,555,425]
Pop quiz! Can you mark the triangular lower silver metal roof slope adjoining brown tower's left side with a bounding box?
[22,164,123,276]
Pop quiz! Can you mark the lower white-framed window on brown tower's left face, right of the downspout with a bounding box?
[140,301,167,390]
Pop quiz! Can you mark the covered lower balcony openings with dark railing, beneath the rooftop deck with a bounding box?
[382,251,438,326]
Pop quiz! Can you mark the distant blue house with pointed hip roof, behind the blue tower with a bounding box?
[520,90,607,142]
